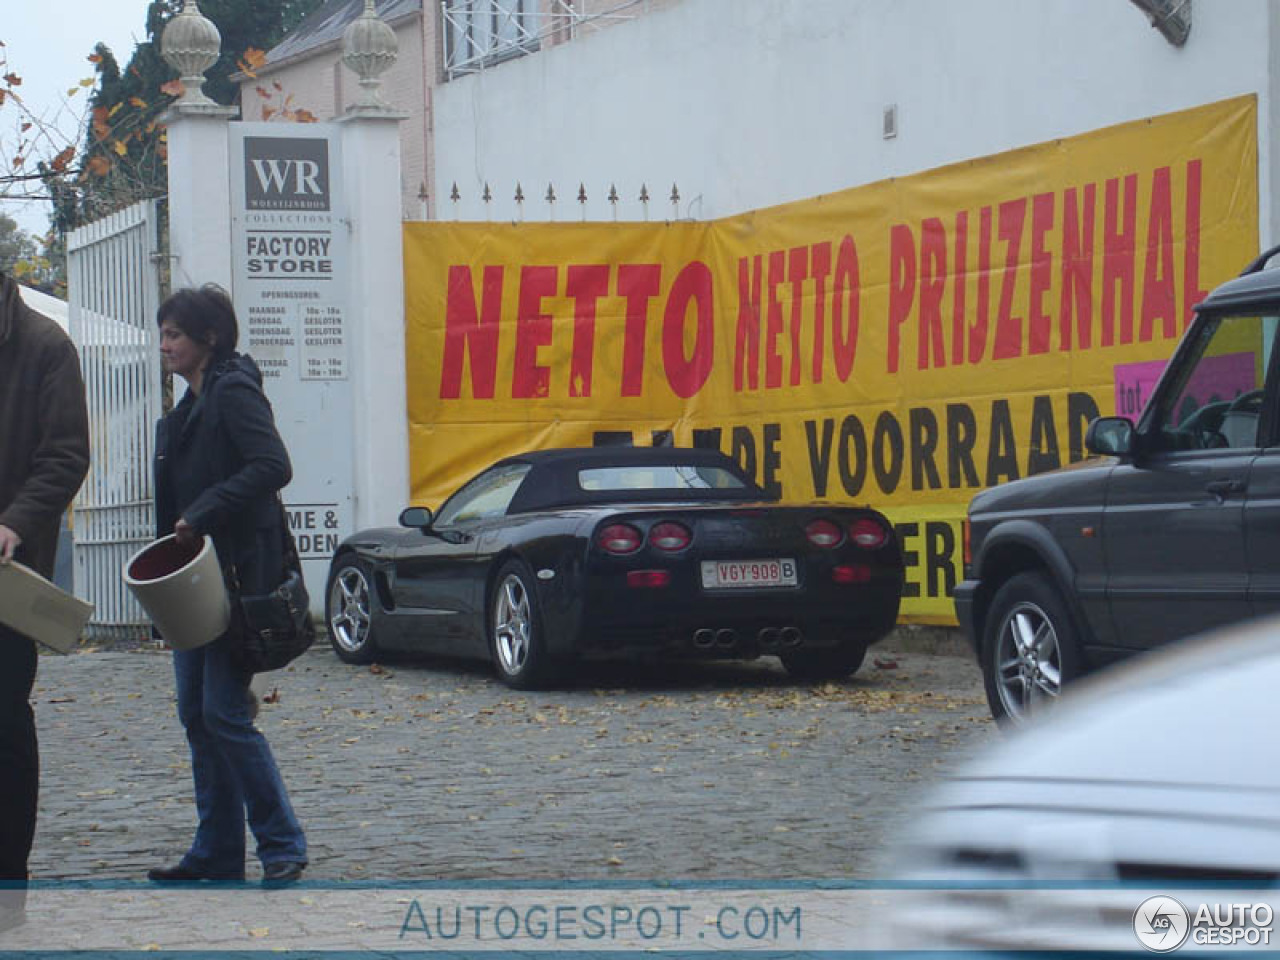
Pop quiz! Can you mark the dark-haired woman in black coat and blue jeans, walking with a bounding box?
[147,284,307,886]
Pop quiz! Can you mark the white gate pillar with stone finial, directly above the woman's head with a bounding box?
[160,0,239,291]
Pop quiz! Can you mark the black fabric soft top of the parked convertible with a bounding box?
[494,447,769,513]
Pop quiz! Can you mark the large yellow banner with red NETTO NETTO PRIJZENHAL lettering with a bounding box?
[404,96,1258,623]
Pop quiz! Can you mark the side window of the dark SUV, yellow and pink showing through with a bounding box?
[1147,316,1280,451]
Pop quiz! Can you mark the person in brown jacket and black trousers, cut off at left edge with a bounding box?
[0,273,88,929]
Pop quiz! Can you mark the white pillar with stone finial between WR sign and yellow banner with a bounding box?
[338,0,408,530]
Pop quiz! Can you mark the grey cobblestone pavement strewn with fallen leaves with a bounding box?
[32,640,996,883]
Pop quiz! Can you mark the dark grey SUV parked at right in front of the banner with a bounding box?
[955,247,1280,721]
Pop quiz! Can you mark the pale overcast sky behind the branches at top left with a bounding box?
[0,0,148,234]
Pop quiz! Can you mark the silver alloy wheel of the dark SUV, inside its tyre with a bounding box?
[996,600,1062,719]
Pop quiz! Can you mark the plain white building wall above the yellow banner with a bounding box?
[434,0,1280,239]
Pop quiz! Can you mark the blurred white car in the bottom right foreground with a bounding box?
[884,620,1280,951]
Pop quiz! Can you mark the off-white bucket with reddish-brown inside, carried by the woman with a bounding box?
[124,534,232,650]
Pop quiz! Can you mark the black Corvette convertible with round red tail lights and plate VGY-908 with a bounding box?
[325,447,902,689]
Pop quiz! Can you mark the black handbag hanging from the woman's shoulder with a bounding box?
[232,498,316,673]
